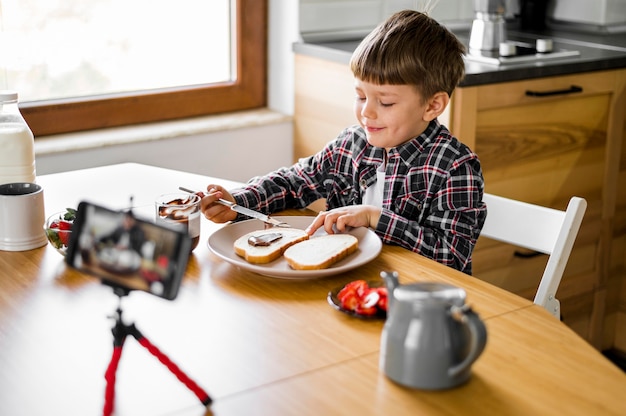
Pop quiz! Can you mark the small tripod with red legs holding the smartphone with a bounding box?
[103,287,212,416]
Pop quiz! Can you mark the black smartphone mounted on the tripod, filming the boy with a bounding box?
[65,201,191,300]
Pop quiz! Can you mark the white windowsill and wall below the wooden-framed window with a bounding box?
[35,110,293,182]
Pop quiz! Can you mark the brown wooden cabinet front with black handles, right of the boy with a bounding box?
[451,71,626,348]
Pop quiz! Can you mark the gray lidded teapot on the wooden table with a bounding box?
[380,272,487,390]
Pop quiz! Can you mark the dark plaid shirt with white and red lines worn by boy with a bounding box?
[232,121,486,274]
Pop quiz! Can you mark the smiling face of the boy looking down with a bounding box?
[354,78,437,149]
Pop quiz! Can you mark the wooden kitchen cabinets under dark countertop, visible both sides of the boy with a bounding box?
[294,55,626,351]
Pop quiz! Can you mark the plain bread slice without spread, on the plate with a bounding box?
[284,234,359,270]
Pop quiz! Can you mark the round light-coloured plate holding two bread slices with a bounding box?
[208,216,382,279]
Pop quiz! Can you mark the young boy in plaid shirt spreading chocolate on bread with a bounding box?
[202,10,486,274]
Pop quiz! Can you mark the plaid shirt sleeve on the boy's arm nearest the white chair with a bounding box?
[376,155,486,274]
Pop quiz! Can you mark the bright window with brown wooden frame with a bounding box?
[0,0,267,136]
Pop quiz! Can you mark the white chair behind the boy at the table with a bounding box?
[481,193,587,319]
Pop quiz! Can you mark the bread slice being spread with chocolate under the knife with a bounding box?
[233,227,309,264]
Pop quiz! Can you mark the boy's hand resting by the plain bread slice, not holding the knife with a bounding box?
[306,205,381,235]
